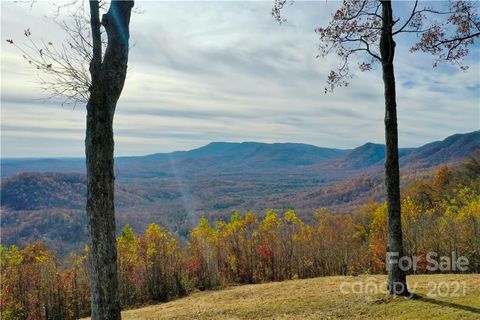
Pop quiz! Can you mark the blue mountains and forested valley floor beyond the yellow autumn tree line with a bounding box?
[1,131,480,251]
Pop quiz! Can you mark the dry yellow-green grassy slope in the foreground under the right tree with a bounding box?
[113,274,480,320]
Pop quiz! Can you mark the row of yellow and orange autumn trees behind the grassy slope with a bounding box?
[1,154,480,319]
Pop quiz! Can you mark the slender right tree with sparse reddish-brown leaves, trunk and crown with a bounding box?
[272,0,480,295]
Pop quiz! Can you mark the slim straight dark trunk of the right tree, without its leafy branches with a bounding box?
[380,1,408,295]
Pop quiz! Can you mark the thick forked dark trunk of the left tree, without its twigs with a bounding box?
[85,0,133,320]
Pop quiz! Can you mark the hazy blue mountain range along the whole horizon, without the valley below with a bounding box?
[1,131,480,179]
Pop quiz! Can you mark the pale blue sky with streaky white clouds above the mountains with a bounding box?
[1,0,480,158]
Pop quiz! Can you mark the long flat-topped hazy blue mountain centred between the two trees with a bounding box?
[116,142,346,178]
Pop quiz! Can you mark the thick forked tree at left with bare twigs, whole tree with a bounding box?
[7,0,134,320]
